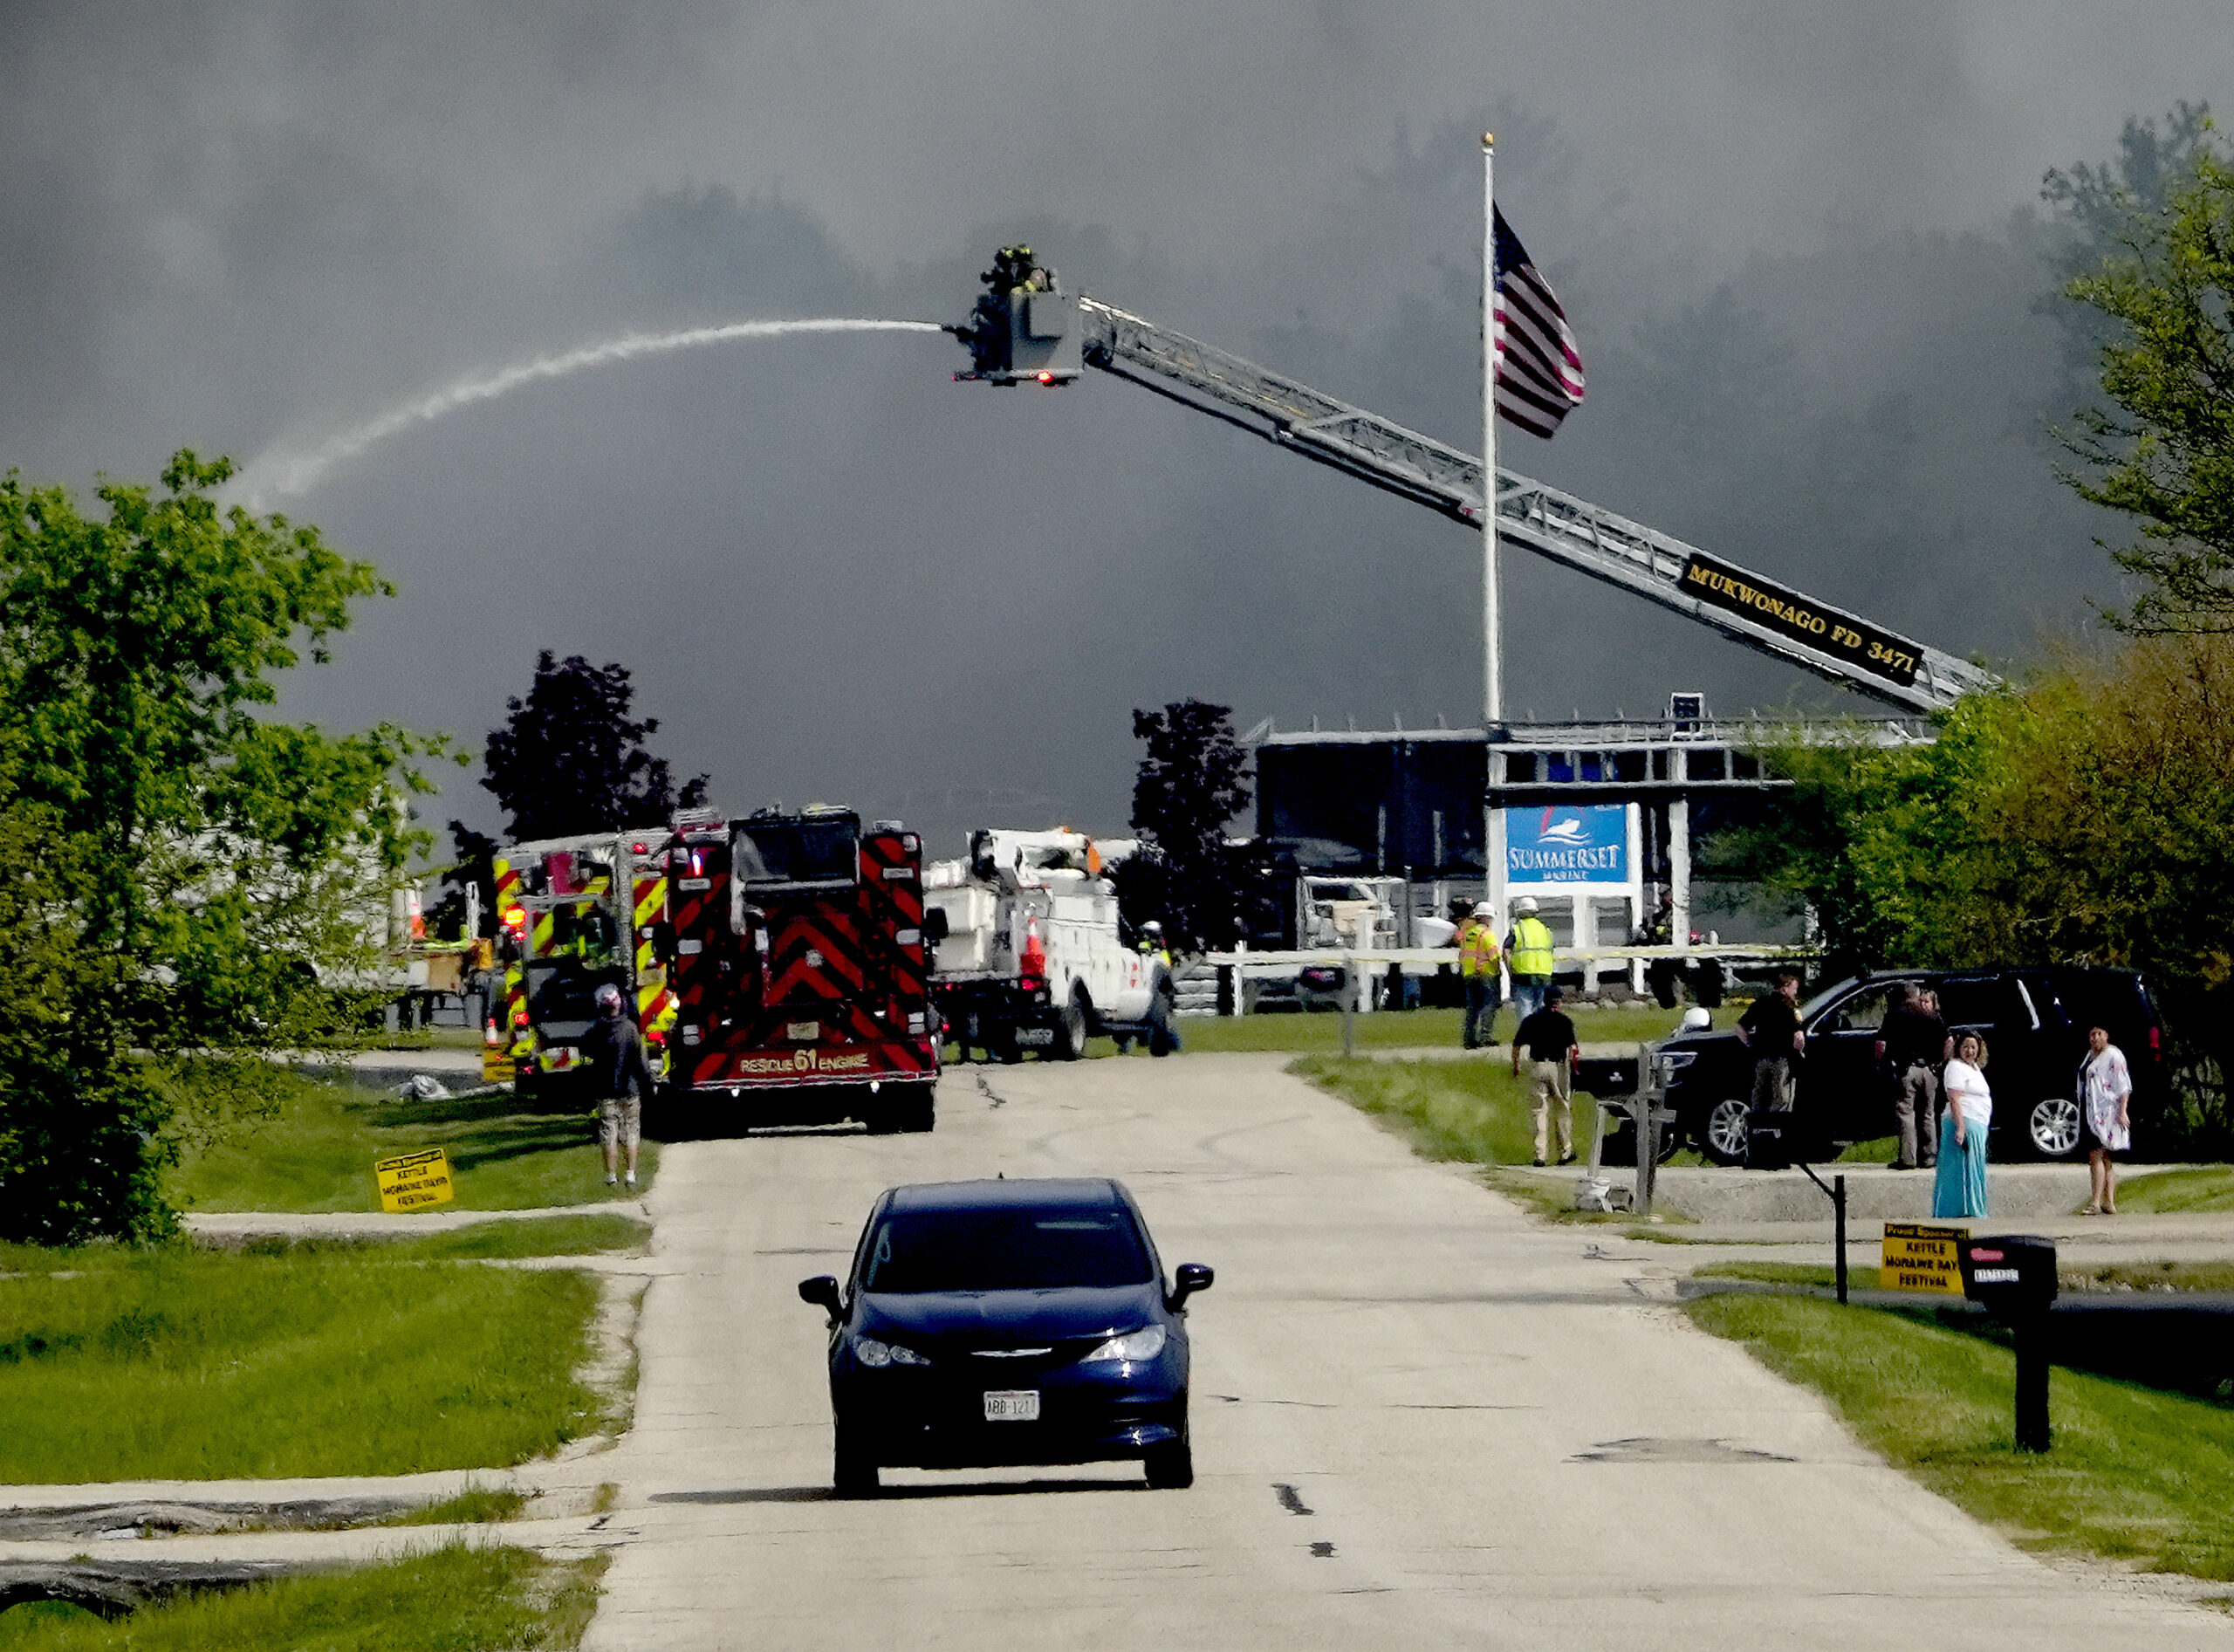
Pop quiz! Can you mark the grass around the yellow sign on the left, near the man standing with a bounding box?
[170,1078,659,1211]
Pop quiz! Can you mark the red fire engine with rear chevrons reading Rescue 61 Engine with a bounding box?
[666,809,938,1134]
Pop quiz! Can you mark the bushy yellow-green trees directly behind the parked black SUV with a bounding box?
[1716,634,2234,1147]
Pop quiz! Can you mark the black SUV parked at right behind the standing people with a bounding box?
[1644,968,2169,1165]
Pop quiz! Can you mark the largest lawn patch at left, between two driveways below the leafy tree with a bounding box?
[0,1245,607,1484]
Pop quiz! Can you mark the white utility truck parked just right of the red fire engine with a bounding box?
[922,829,1177,1062]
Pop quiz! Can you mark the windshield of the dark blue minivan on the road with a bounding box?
[860,1205,1155,1297]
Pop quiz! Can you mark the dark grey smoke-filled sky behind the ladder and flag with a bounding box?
[0,0,2234,847]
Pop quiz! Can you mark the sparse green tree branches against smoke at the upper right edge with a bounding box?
[2046,105,2234,633]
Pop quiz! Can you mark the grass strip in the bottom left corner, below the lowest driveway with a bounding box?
[0,1547,607,1652]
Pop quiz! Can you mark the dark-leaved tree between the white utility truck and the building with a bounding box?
[1114,700,1260,952]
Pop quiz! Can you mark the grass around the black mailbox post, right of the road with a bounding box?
[1687,1292,2234,1580]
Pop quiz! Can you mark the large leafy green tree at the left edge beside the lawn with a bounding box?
[0,451,440,1243]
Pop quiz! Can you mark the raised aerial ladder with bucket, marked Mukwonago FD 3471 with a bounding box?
[947,248,1999,716]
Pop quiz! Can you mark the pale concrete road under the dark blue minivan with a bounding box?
[586,1055,2234,1652]
